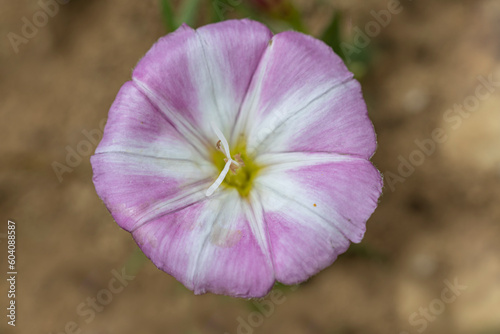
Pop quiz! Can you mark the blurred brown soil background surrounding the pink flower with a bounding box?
[0,0,500,334]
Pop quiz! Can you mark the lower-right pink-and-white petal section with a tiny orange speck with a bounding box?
[255,153,382,284]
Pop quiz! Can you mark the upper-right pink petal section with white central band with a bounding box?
[233,32,376,158]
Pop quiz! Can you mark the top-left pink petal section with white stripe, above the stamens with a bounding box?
[133,20,272,145]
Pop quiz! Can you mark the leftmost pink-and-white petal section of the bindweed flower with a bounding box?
[91,82,217,231]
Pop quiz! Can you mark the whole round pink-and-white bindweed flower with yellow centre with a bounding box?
[91,20,382,297]
